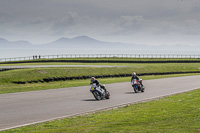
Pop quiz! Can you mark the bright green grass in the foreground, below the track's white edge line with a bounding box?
[3,89,200,133]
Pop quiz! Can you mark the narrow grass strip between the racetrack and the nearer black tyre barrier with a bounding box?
[0,74,198,94]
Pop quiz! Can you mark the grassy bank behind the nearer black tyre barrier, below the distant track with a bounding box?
[0,63,200,83]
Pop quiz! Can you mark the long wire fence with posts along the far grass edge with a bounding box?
[0,54,200,62]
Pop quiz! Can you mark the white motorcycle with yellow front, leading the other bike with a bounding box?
[90,83,110,100]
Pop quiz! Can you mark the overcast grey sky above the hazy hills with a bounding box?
[0,0,200,45]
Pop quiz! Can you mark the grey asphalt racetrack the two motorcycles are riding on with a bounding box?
[0,75,200,131]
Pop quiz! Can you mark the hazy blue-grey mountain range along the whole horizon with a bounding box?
[0,36,200,49]
